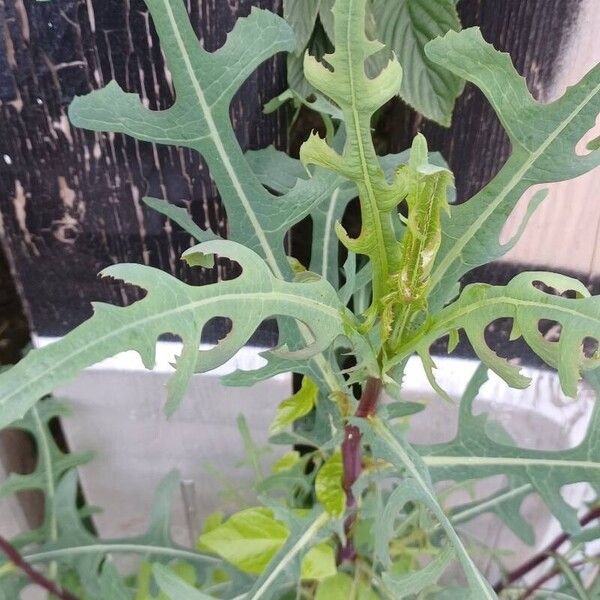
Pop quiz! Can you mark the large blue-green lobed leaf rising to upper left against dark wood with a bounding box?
[69,0,350,398]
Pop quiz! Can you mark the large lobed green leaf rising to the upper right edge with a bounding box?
[425,28,600,309]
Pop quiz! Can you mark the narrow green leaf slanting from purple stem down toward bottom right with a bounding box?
[366,417,497,600]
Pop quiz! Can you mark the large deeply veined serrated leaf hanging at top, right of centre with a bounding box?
[372,0,464,127]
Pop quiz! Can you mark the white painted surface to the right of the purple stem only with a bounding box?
[405,358,595,581]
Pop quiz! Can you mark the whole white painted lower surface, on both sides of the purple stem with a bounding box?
[31,340,593,578]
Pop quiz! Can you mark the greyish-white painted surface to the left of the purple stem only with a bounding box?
[38,339,291,544]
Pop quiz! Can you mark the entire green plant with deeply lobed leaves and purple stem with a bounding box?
[0,0,600,600]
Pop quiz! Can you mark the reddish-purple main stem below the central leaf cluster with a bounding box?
[338,377,382,563]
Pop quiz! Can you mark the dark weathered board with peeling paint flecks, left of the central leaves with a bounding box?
[0,0,286,343]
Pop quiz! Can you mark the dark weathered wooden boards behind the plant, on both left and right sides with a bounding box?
[0,0,597,352]
